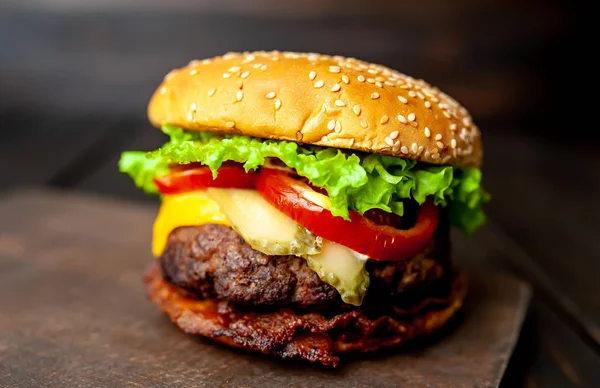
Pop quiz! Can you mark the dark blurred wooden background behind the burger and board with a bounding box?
[0,0,600,387]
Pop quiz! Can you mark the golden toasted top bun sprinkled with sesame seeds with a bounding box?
[148,52,482,167]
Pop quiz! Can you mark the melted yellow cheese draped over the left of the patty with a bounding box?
[152,191,229,257]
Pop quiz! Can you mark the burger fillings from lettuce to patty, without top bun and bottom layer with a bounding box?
[119,126,488,308]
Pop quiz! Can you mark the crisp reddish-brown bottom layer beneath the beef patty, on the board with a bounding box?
[145,264,467,367]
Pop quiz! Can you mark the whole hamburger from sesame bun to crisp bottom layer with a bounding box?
[119,52,489,367]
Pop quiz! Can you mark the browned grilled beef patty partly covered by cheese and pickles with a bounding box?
[160,224,448,309]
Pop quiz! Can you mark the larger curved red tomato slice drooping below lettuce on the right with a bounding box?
[256,168,439,261]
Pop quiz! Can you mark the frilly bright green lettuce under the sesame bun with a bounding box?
[119,125,489,233]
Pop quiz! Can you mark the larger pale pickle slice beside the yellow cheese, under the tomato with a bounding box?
[206,188,323,255]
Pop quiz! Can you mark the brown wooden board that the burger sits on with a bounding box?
[0,189,530,388]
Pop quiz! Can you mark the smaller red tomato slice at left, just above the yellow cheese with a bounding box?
[154,165,257,194]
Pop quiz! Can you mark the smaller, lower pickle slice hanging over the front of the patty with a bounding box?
[305,240,370,306]
